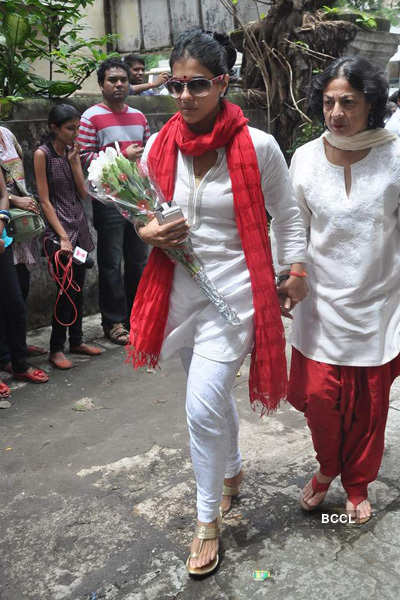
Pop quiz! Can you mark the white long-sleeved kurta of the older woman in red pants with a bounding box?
[290,137,400,366]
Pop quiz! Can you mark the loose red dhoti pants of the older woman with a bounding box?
[288,348,400,501]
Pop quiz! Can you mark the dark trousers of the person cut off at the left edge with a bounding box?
[0,246,28,373]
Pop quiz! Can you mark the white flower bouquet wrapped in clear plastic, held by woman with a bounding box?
[88,147,240,325]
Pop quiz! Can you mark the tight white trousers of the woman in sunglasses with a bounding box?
[180,348,244,523]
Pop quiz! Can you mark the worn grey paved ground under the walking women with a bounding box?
[0,317,400,600]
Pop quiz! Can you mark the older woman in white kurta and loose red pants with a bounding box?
[288,57,400,522]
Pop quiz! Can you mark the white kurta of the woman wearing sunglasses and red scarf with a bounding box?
[142,128,305,362]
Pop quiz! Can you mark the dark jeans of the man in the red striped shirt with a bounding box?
[93,201,148,330]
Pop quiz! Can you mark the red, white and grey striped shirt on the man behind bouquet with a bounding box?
[77,104,150,168]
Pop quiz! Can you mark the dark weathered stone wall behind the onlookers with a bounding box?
[0,92,266,328]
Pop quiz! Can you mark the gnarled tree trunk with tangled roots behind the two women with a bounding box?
[231,0,357,151]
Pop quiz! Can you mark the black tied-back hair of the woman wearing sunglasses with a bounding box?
[169,29,236,76]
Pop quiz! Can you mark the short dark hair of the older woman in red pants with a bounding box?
[309,56,388,129]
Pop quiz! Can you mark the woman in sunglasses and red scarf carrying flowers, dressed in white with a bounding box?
[131,31,306,575]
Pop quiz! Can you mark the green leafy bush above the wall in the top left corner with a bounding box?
[0,0,115,101]
